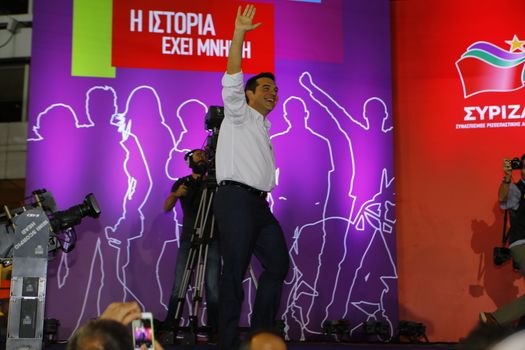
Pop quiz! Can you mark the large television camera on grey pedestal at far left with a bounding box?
[0,189,100,350]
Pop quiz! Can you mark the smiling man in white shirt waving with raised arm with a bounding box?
[214,5,289,350]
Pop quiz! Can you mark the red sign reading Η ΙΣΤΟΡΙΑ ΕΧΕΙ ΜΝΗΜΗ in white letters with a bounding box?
[112,0,274,73]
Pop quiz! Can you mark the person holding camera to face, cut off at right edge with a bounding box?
[480,154,525,325]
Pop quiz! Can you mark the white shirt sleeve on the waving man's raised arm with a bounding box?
[222,72,248,124]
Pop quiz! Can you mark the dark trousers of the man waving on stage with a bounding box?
[213,185,289,350]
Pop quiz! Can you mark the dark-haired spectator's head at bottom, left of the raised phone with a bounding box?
[67,320,133,350]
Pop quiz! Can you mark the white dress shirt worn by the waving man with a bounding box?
[216,72,275,192]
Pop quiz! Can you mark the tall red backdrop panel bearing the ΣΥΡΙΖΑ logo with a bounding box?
[391,0,525,342]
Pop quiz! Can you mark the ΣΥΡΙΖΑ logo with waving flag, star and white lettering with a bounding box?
[456,35,525,129]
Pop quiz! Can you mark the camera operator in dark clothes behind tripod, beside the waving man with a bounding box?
[162,149,220,337]
